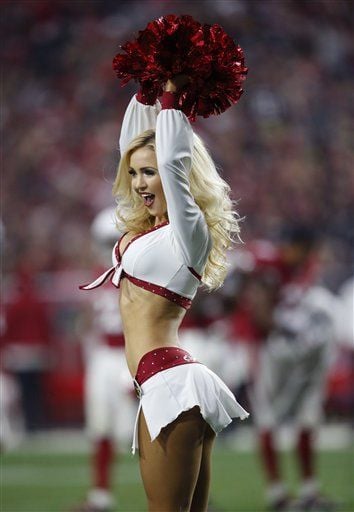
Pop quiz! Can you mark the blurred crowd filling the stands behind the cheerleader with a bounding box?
[2,0,354,278]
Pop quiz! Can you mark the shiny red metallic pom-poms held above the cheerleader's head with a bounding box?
[113,14,248,121]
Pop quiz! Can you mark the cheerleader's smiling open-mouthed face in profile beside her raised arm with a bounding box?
[128,146,167,225]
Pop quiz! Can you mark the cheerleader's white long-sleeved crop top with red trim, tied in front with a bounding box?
[80,96,212,309]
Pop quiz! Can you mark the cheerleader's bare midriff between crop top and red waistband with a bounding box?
[119,279,186,377]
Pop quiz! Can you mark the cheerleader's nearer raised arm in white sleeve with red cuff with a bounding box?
[156,79,211,271]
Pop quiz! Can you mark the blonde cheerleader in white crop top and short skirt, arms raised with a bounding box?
[82,75,248,512]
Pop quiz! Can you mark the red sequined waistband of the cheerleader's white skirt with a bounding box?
[135,347,198,386]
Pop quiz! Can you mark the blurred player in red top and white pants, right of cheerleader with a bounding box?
[232,224,338,511]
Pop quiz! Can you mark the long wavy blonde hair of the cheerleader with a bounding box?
[112,130,240,290]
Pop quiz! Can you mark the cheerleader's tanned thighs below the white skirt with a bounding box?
[139,407,206,512]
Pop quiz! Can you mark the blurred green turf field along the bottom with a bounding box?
[0,443,354,512]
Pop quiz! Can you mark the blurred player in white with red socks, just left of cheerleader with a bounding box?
[73,208,137,512]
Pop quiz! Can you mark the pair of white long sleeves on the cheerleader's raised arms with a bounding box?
[119,96,211,272]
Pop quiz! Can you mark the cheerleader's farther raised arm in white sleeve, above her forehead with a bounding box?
[119,93,161,155]
